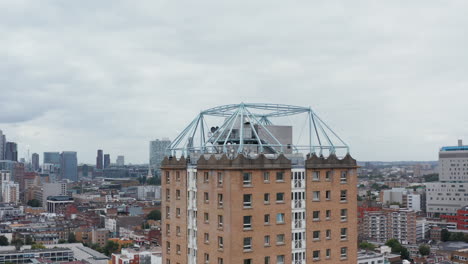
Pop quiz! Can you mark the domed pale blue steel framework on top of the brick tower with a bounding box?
[168,103,349,156]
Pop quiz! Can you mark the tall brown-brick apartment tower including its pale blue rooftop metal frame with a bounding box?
[161,104,357,264]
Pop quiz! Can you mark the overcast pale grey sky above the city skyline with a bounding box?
[0,0,468,163]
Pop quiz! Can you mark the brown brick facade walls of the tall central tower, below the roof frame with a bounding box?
[162,155,357,264]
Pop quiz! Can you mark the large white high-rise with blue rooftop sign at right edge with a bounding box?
[426,140,468,215]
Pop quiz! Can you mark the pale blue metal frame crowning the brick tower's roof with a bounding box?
[168,103,349,156]
